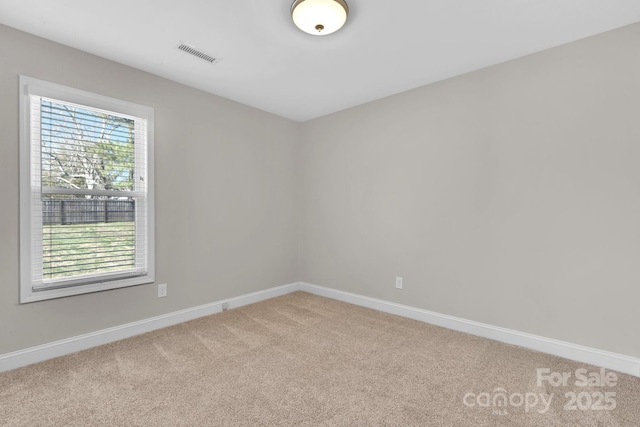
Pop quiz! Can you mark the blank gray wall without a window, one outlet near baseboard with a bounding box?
[300,24,640,357]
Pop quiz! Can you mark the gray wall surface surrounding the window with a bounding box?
[0,26,299,354]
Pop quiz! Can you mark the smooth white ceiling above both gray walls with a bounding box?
[0,0,640,121]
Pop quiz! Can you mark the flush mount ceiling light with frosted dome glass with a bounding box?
[291,0,349,36]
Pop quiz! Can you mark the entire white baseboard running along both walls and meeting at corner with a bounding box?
[0,282,640,377]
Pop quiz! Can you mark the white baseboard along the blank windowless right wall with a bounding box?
[300,283,640,377]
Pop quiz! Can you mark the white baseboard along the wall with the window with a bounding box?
[0,283,300,372]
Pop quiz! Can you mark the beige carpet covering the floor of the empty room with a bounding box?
[0,292,640,427]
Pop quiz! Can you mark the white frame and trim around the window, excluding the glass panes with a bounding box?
[19,76,155,304]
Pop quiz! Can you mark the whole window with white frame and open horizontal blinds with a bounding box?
[20,76,154,303]
